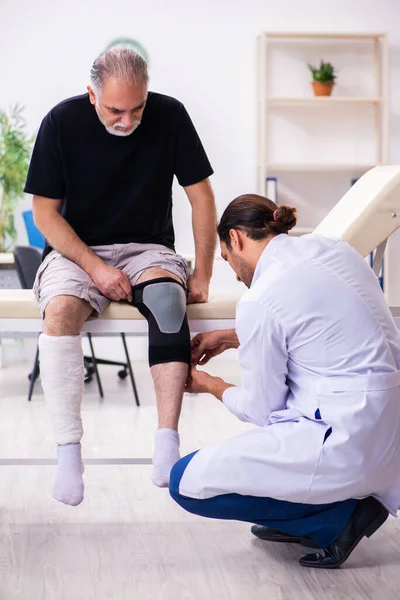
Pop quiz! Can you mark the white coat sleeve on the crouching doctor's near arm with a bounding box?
[222,302,288,427]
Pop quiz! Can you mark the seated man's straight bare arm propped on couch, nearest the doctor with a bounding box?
[184,179,217,303]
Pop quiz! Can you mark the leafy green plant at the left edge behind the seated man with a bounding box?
[0,105,33,252]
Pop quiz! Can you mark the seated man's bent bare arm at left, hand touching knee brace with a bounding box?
[33,196,132,301]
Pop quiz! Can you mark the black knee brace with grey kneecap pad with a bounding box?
[132,277,191,367]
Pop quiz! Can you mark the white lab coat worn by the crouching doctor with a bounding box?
[180,234,400,514]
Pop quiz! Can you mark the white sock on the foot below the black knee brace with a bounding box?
[151,429,181,487]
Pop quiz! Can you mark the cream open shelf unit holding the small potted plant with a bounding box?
[257,32,389,296]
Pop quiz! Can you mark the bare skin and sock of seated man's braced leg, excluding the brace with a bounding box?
[137,268,189,487]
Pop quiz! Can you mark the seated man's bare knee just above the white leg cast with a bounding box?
[44,296,92,336]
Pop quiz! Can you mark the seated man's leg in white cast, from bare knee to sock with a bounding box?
[39,296,93,506]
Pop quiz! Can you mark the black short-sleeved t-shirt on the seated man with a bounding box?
[24,92,213,248]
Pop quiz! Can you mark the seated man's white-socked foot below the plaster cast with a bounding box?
[53,444,84,506]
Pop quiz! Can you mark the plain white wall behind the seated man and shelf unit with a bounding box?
[0,0,400,301]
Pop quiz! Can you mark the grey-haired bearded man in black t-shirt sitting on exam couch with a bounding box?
[25,49,216,505]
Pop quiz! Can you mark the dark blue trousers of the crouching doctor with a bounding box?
[169,452,357,548]
